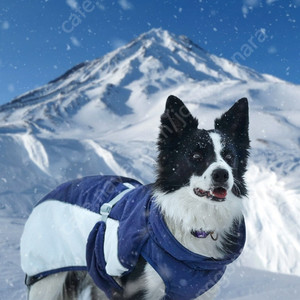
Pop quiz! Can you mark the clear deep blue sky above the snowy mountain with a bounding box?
[0,0,300,104]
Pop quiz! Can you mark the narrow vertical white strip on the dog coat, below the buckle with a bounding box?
[103,218,130,276]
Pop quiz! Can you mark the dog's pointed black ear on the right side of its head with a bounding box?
[215,98,250,148]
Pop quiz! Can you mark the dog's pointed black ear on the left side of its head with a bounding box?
[160,95,198,138]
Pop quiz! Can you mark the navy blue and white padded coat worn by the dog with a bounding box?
[21,176,245,300]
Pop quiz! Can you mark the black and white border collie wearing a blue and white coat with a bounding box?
[21,96,250,300]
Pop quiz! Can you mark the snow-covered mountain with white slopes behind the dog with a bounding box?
[0,29,300,299]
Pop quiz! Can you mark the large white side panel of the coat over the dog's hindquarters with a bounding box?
[20,200,100,276]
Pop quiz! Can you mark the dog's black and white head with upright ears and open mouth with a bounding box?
[156,96,249,204]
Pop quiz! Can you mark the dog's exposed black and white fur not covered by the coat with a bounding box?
[29,96,249,300]
